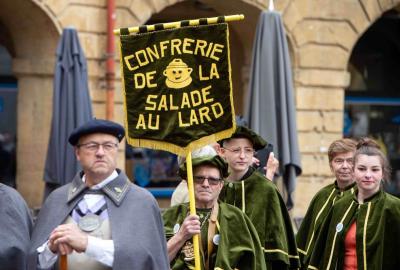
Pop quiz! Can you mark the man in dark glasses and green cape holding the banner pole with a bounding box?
[163,155,266,270]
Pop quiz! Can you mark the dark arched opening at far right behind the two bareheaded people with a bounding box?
[344,10,400,197]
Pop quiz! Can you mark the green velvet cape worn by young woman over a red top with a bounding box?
[308,191,400,270]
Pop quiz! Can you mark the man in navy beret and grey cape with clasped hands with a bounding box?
[28,119,169,270]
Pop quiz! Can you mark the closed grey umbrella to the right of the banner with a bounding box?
[244,11,301,207]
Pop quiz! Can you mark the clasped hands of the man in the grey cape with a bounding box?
[49,224,88,252]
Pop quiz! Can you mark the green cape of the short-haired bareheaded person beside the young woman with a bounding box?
[296,181,356,269]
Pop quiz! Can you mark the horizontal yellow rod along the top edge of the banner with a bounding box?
[113,14,244,36]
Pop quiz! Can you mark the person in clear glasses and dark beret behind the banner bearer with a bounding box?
[220,126,299,270]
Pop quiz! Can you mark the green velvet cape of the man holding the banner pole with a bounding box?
[163,203,266,270]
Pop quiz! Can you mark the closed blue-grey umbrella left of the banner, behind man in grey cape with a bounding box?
[44,28,92,196]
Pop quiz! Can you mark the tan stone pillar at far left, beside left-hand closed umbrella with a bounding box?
[0,0,60,207]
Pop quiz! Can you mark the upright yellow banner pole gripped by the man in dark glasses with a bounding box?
[186,151,201,270]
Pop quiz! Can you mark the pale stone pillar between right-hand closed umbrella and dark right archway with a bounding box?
[283,0,400,216]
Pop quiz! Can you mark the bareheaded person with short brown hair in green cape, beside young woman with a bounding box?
[296,139,356,269]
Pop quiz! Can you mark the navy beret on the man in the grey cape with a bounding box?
[68,118,125,146]
